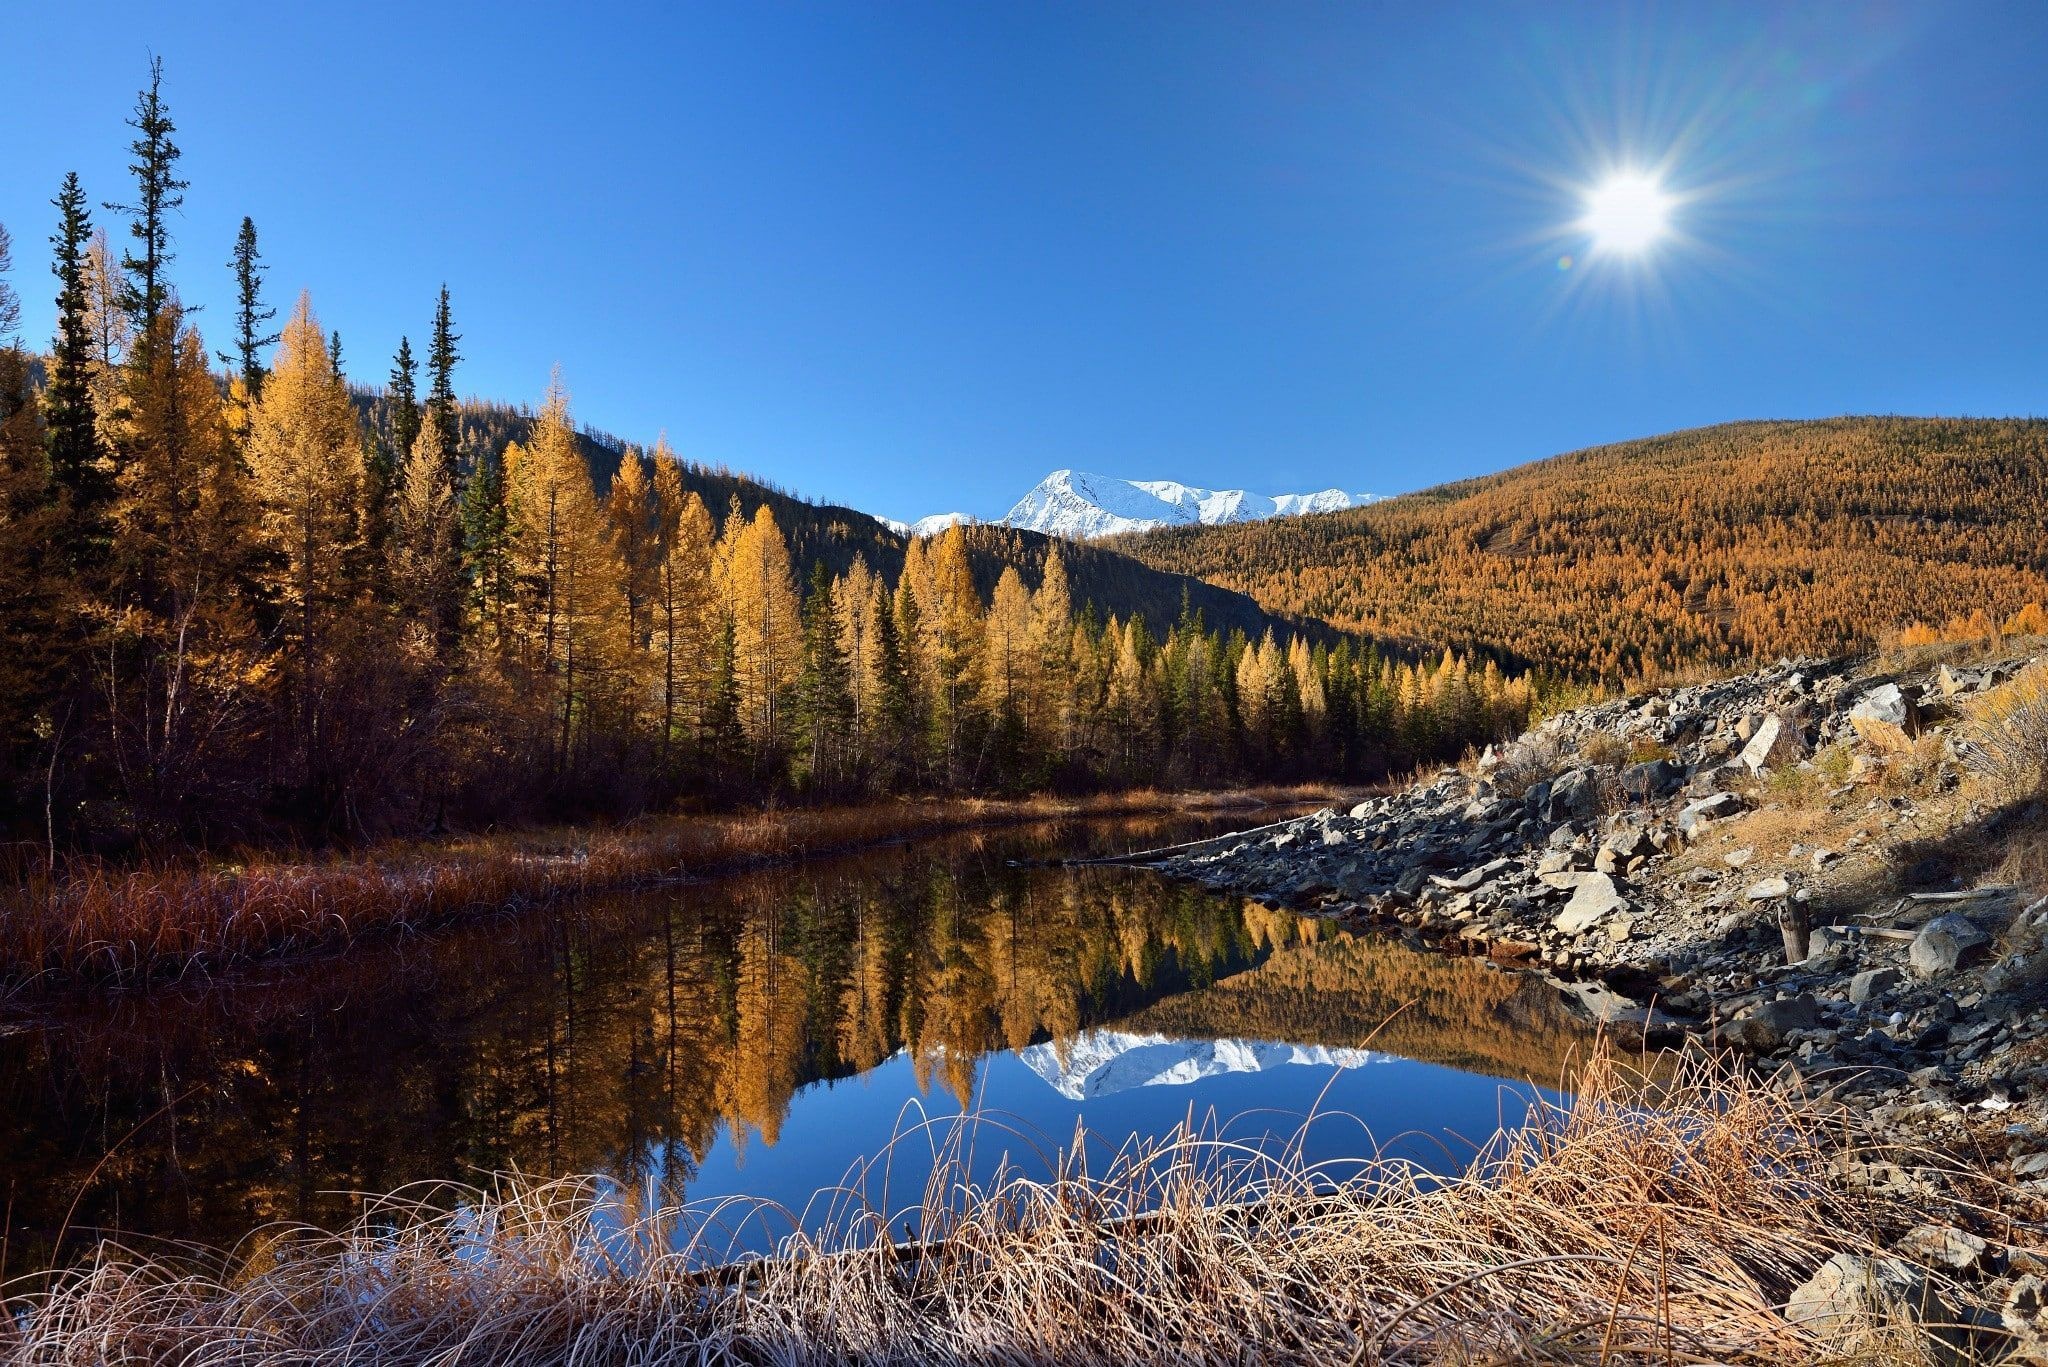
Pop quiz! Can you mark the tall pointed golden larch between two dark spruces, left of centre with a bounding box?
[248,295,365,779]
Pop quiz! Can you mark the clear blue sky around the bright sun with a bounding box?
[0,0,2048,516]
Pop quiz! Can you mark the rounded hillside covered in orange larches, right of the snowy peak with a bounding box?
[1110,418,2048,678]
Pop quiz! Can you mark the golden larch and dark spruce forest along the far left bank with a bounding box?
[0,64,1538,859]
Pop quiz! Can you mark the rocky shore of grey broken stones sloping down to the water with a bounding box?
[1139,654,2048,1363]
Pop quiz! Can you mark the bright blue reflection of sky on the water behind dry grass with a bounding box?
[630,1041,1554,1250]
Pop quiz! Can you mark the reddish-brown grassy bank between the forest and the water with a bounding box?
[0,789,1327,996]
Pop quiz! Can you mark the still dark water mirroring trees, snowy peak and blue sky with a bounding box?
[0,816,1585,1279]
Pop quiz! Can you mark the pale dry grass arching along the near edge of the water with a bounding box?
[0,1060,2015,1367]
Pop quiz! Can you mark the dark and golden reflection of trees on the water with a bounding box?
[0,823,1597,1269]
